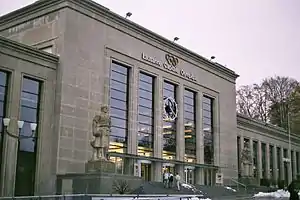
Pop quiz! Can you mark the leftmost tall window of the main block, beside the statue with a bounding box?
[109,62,129,153]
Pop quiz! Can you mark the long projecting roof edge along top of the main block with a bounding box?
[0,0,239,81]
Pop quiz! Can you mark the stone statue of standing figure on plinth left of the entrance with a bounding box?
[91,106,111,161]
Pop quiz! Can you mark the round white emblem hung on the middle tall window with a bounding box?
[163,97,178,121]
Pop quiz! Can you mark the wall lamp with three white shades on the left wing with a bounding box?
[3,118,37,140]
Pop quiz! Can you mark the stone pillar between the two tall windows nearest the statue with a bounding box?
[127,67,139,155]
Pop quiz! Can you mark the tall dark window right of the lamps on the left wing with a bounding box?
[15,77,41,196]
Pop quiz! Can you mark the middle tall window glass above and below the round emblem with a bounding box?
[162,81,177,160]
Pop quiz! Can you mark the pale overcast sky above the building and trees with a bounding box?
[0,0,300,86]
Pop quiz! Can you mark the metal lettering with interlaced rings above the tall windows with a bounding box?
[142,53,196,82]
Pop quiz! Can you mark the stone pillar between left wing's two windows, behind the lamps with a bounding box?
[1,72,22,196]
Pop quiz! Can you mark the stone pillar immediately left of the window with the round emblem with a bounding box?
[153,76,163,158]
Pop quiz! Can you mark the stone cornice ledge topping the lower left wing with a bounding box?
[0,36,59,64]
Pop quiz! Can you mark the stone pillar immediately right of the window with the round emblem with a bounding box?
[176,85,185,161]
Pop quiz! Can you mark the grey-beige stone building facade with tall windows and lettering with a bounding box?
[0,0,299,196]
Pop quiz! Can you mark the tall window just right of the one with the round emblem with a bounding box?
[183,90,196,162]
